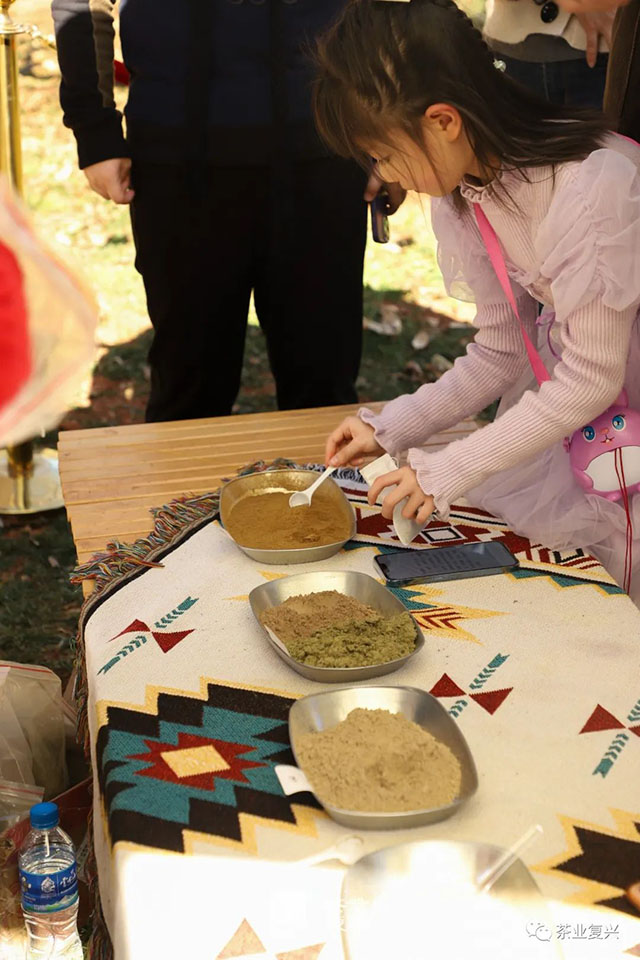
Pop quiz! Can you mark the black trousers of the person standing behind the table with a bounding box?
[131,158,367,421]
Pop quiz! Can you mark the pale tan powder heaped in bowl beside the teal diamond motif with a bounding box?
[296,708,462,813]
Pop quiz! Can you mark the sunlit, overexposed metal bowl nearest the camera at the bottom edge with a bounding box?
[341,840,556,960]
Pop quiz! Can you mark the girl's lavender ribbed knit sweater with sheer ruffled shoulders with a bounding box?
[360,135,640,517]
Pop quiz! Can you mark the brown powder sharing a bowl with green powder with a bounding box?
[260,592,382,646]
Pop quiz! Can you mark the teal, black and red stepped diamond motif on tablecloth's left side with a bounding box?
[97,682,322,853]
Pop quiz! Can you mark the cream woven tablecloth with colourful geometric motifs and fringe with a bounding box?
[82,475,640,960]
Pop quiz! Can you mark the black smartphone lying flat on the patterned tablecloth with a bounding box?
[374,540,519,587]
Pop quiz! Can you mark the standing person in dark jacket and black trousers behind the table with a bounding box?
[52,0,400,420]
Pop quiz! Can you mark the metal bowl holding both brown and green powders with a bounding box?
[249,570,424,683]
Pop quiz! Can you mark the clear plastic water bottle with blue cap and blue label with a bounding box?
[18,803,83,960]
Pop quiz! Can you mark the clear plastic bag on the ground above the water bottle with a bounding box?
[0,660,67,798]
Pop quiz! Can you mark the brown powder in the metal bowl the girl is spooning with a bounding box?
[227,490,351,550]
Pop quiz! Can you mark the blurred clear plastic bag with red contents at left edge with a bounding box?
[0,179,97,447]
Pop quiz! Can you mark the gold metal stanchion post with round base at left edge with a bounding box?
[0,0,64,514]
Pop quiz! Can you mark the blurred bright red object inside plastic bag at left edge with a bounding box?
[0,243,31,410]
